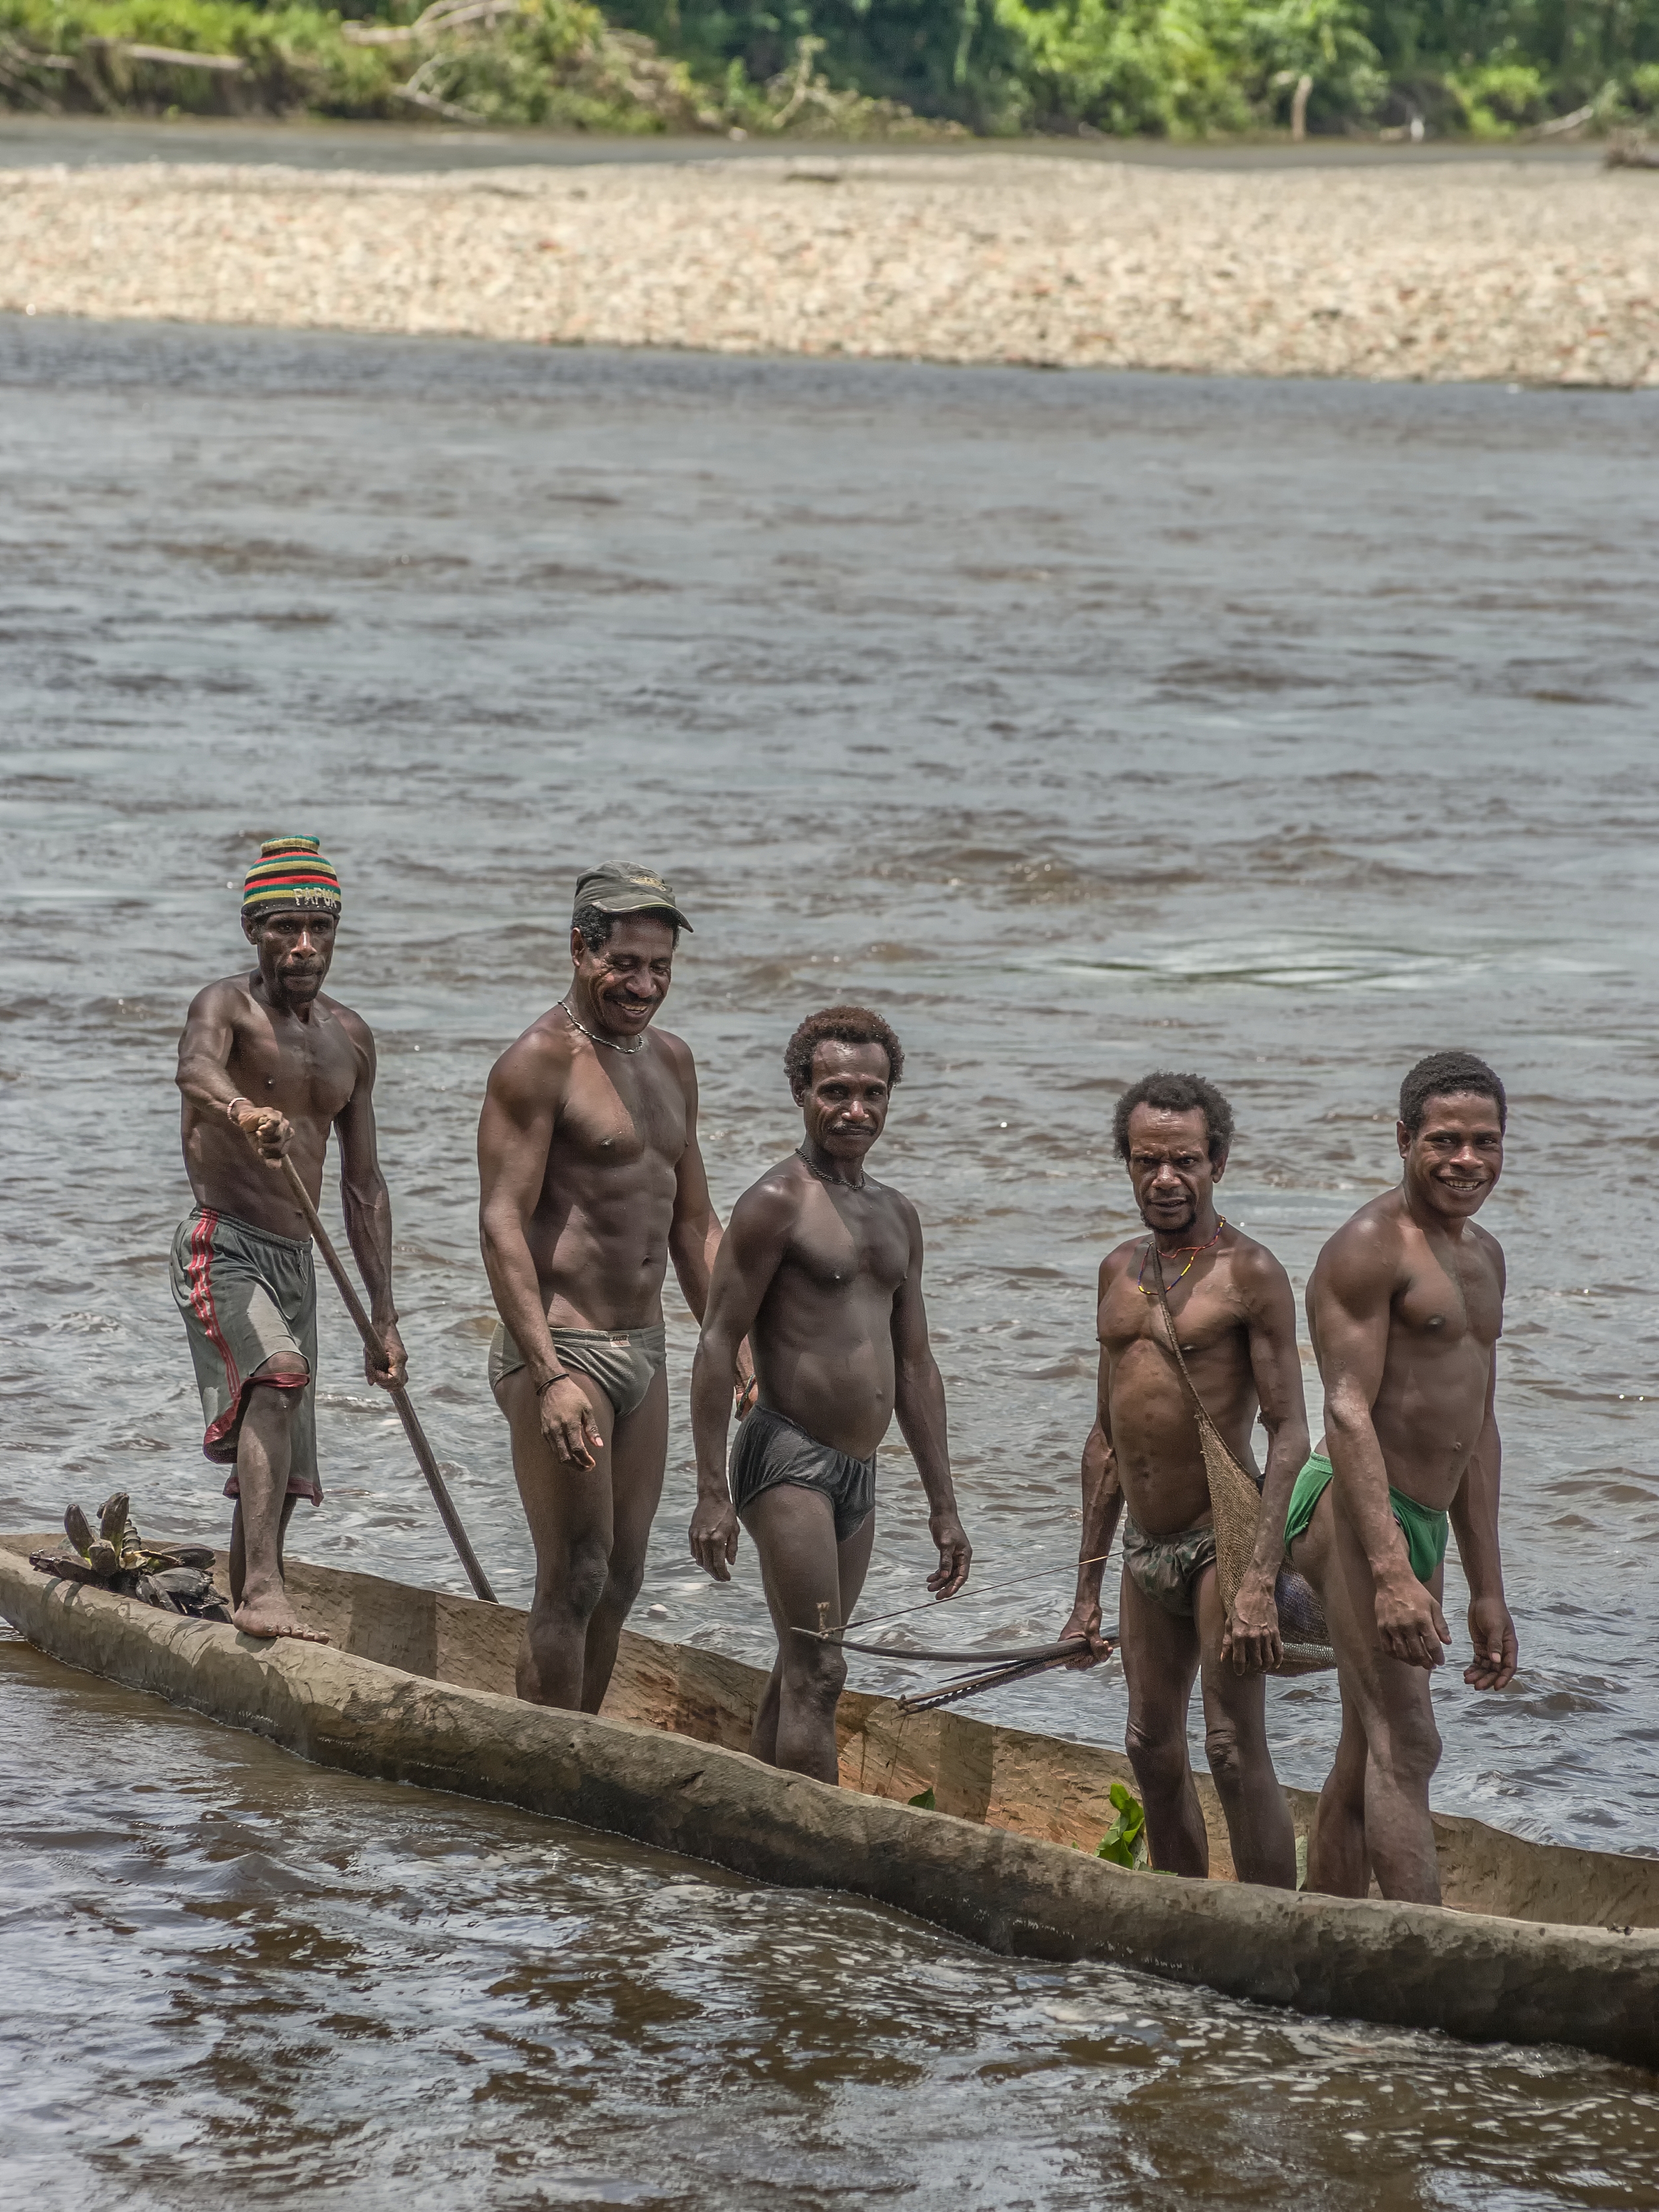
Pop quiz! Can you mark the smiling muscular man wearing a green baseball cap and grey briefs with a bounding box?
[478,861,752,1712]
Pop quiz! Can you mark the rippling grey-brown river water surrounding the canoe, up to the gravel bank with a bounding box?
[0,307,1659,2212]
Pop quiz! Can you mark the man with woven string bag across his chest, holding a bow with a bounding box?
[1062,1073,1307,1889]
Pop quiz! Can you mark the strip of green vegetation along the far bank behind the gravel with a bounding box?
[0,0,1659,137]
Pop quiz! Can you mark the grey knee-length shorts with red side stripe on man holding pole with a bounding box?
[171,1206,323,1506]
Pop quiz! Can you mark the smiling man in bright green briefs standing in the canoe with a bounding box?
[1285,1053,1515,1905]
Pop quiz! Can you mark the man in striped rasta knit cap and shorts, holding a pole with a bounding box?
[173,836,405,1643]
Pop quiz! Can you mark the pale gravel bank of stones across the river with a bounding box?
[0,153,1659,385]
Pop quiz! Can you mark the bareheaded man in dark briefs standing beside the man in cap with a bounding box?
[690,1006,971,1783]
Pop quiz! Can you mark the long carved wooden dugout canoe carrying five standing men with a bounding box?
[0,1535,1659,2071]
